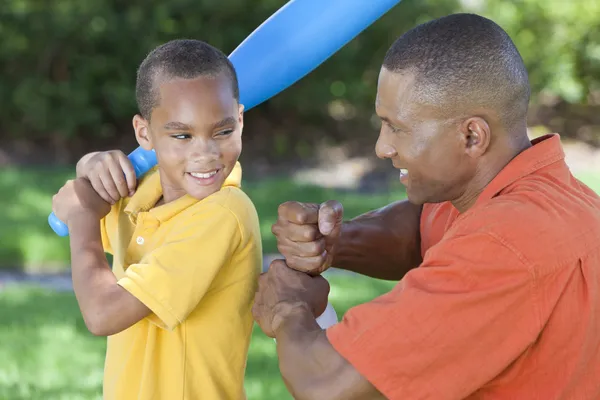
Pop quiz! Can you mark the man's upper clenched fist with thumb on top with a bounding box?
[271,200,344,275]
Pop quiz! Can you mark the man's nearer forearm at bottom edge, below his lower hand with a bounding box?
[275,305,384,400]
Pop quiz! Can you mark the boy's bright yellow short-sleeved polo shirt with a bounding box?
[102,164,262,400]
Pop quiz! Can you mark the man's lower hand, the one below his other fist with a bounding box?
[252,260,329,337]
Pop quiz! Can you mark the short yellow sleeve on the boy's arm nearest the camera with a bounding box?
[119,203,243,330]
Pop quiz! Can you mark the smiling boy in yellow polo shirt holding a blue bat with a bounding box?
[53,40,262,400]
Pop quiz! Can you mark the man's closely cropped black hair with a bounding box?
[383,14,530,128]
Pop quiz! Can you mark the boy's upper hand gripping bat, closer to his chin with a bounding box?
[77,150,137,204]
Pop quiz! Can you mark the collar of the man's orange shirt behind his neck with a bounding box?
[475,133,565,205]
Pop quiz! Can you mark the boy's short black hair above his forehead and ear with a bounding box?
[135,39,240,120]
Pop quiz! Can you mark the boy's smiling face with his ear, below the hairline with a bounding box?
[134,74,243,202]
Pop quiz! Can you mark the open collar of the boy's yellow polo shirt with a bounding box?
[124,162,242,224]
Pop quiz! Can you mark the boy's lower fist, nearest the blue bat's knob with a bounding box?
[52,178,110,225]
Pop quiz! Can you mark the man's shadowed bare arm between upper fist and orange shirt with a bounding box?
[333,201,422,280]
